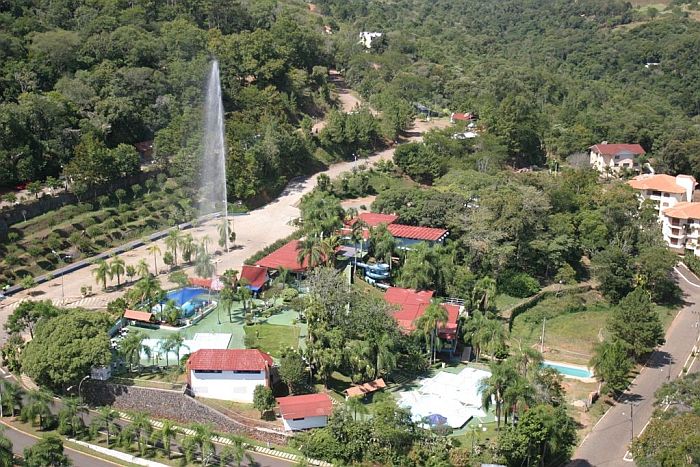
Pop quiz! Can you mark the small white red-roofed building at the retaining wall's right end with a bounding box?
[277,394,333,431]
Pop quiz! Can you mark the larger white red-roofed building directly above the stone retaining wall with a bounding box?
[187,349,273,403]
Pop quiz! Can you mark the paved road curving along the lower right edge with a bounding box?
[569,266,700,467]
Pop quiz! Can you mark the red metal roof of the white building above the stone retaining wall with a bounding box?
[187,349,273,371]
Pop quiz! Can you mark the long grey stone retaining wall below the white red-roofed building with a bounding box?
[83,381,287,444]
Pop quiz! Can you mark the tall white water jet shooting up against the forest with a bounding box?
[200,60,229,251]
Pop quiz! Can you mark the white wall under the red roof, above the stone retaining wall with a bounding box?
[190,371,267,403]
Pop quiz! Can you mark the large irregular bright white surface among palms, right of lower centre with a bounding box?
[399,368,491,428]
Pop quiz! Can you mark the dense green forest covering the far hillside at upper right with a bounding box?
[318,0,700,175]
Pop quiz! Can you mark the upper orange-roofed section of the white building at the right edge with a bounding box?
[627,174,697,216]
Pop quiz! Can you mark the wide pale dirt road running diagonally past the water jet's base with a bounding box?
[0,97,449,330]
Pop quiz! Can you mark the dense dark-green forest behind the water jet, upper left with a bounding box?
[0,0,356,198]
